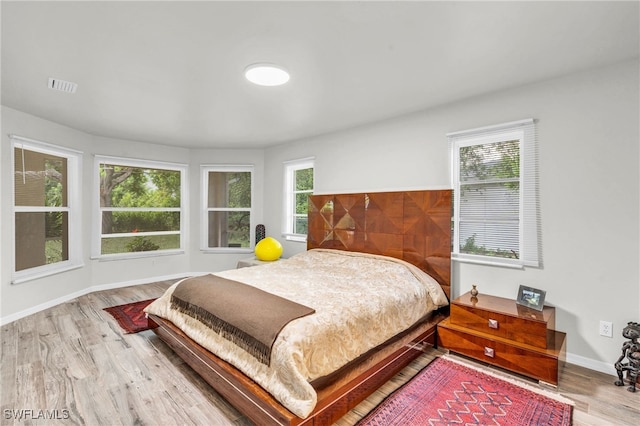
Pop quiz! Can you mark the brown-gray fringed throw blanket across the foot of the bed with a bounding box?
[171,275,315,365]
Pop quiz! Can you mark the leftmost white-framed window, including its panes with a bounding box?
[11,136,82,283]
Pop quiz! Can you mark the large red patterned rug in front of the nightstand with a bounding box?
[358,358,573,426]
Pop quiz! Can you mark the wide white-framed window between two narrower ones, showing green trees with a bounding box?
[94,156,187,258]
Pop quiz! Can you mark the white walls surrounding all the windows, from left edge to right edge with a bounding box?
[0,61,640,372]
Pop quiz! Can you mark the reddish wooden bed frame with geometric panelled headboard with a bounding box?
[149,190,451,425]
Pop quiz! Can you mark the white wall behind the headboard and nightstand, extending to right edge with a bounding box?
[265,61,640,372]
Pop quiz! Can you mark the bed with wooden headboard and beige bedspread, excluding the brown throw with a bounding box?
[147,190,451,425]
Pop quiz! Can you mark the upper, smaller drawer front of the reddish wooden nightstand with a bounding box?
[451,303,547,348]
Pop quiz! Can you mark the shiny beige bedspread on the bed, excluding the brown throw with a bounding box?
[146,249,448,418]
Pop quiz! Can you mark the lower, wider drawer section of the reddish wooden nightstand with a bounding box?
[438,319,566,385]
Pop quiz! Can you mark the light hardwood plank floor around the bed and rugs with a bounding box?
[0,281,640,426]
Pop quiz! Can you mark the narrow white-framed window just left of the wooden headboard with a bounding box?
[282,158,313,241]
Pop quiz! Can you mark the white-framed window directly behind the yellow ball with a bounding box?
[201,166,254,251]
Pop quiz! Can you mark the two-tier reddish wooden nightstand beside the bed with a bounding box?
[438,293,566,386]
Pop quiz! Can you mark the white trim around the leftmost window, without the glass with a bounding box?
[9,135,84,284]
